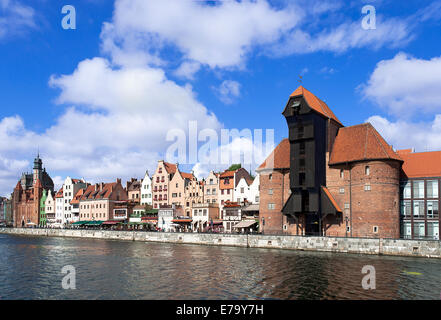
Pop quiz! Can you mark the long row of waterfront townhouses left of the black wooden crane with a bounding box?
[9,157,259,230]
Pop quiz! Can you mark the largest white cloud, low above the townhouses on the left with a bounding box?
[0,58,221,193]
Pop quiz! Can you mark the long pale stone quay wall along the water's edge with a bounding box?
[0,228,441,258]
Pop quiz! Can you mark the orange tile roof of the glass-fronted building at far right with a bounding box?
[397,150,441,178]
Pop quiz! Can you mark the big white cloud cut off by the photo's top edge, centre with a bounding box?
[103,0,300,68]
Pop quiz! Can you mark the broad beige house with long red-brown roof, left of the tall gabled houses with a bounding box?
[79,179,128,221]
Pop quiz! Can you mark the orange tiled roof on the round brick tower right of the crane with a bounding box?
[329,123,403,165]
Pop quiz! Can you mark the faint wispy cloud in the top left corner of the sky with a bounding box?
[0,0,36,39]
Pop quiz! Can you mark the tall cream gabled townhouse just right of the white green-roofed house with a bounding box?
[152,160,177,209]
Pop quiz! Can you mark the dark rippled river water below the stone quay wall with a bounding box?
[0,234,441,299]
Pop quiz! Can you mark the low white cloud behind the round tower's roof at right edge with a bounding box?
[367,114,441,152]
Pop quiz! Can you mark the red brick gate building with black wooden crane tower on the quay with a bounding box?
[257,87,416,238]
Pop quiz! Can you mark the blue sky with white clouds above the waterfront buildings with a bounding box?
[0,0,441,195]
